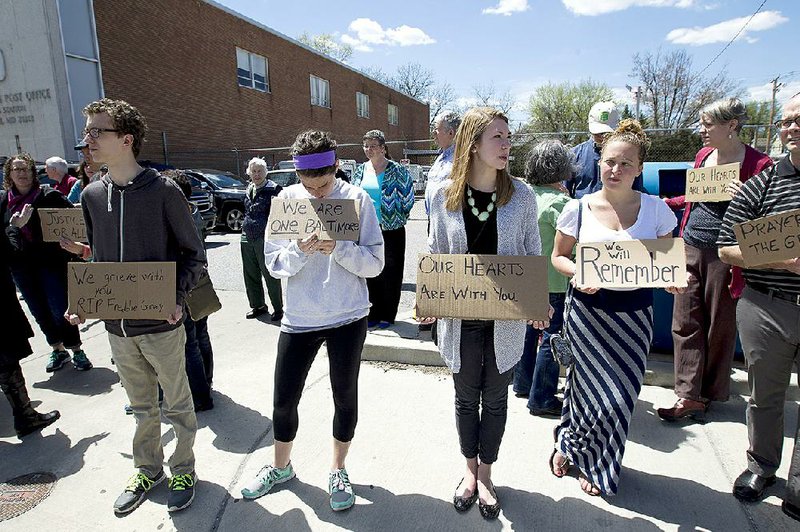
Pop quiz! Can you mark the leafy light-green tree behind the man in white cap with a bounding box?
[525,79,614,143]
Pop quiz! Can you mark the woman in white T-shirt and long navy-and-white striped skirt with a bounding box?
[550,120,682,495]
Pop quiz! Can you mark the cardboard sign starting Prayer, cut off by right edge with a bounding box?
[733,209,800,267]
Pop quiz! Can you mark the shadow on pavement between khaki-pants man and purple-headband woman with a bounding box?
[197,390,273,454]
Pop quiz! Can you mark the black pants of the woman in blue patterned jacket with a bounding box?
[367,227,406,323]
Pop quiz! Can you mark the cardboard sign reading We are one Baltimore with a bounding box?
[267,198,361,241]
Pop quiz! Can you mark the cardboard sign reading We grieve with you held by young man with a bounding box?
[67,262,177,320]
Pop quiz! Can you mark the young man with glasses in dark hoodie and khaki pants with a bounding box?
[68,98,205,514]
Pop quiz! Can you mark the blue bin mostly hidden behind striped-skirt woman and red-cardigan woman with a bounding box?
[642,162,744,359]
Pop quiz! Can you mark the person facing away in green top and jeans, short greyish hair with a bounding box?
[514,140,576,417]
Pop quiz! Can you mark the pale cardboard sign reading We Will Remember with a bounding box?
[575,238,687,288]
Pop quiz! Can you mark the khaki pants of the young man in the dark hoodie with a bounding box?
[108,327,197,477]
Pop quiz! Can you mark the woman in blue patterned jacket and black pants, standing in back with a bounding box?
[352,129,414,329]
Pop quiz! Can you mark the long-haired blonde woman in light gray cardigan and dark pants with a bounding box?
[420,107,547,519]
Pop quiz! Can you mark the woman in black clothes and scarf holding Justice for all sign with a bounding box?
[0,153,92,373]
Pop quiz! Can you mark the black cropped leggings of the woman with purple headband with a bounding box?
[272,318,367,442]
